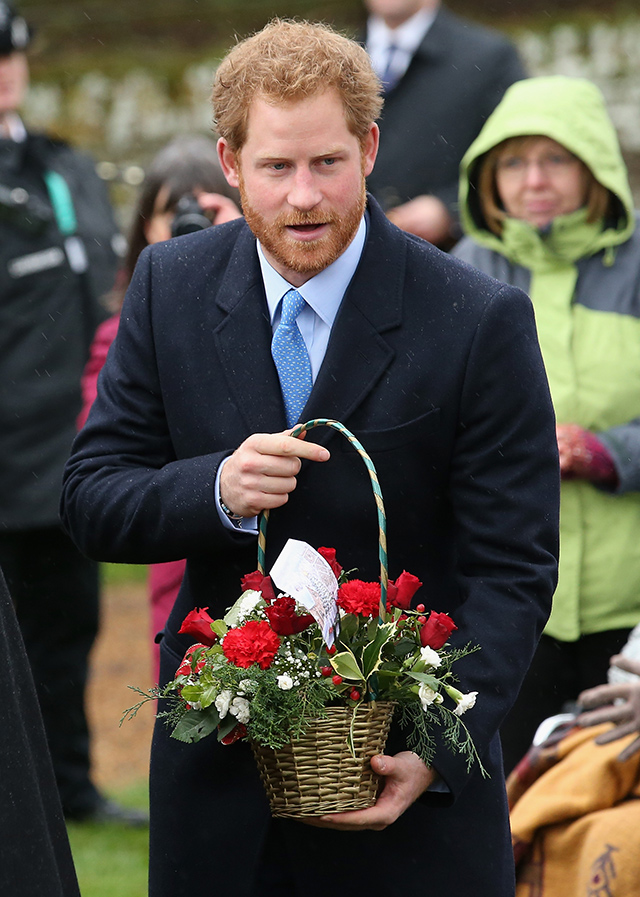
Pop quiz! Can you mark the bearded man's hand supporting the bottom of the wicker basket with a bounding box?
[301,751,436,832]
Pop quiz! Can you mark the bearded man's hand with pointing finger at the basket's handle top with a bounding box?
[220,430,329,517]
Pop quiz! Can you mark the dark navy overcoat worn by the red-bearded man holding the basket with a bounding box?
[62,201,559,897]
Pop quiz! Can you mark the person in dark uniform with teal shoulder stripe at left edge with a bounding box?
[0,0,144,823]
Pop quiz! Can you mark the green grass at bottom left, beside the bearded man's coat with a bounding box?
[67,781,149,897]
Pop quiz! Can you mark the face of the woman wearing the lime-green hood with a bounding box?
[496,137,589,228]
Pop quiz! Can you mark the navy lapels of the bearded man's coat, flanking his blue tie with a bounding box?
[214,197,407,442]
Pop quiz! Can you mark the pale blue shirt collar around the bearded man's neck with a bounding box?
[257,217,367,327]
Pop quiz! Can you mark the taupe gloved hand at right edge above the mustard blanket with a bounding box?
[576,654,640,760]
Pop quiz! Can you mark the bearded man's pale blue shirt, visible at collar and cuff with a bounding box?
[214,217,367,535]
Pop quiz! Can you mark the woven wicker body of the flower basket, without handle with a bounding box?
[251,701,394,818]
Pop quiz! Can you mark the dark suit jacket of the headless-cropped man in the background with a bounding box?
[368,7,526,217]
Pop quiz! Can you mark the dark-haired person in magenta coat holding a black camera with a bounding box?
[78,136,240,682]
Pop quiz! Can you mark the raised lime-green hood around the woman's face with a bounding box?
[460,75,635,254]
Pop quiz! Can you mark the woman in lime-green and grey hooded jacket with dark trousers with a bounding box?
[454,76,640,771]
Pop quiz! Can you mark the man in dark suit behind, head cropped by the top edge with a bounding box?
[365,0,526,248]
